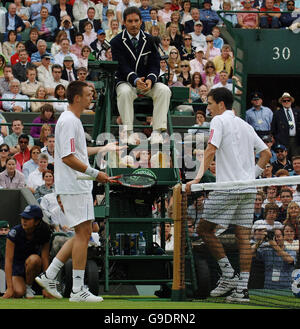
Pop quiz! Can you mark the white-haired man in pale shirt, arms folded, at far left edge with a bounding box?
[2,79,30,112]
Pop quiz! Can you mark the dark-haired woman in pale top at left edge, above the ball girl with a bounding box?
[0,157,25,188]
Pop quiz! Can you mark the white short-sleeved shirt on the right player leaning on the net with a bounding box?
[208,110,267,186]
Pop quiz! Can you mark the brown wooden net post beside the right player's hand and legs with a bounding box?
[171,184,186,301]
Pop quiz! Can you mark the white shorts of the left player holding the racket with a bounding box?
[60,193,95,227]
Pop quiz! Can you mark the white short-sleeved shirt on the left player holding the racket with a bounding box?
[54,110,93,194]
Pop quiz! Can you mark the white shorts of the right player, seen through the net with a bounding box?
[203,192,256,228]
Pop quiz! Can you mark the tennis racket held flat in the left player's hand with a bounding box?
[77,174,156,188]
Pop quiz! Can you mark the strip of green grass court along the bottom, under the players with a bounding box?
[0,296,295,310]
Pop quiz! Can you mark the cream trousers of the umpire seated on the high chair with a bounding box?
[116,82,171,131]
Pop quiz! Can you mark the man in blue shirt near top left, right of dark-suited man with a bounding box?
[34,6,57,42]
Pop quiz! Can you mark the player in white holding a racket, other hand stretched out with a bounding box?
[35,81,118,302]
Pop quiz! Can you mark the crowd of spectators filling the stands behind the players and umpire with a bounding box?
[0,0,300,294]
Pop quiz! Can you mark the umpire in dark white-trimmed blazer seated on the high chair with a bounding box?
[111,7,171,144]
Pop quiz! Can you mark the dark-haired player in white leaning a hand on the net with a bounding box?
[186,88,271,302]
